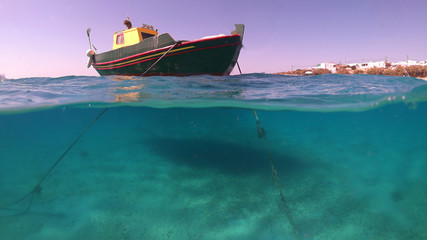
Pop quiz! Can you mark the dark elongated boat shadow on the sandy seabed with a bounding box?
[144,138,316,176]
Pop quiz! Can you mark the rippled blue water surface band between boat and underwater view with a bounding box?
[0,74,427,111]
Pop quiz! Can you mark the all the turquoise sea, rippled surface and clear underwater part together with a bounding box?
[0,74,427,240]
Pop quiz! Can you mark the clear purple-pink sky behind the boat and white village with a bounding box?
[0,0,427,78]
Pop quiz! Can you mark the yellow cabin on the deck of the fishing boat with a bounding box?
[113,24,158,50]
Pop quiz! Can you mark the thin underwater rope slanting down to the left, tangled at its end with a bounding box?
[0,108,108,217]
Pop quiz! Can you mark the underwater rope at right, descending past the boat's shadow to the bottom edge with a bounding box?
[253,110,302,240]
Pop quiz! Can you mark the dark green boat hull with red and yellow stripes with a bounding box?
[93,29,243,76]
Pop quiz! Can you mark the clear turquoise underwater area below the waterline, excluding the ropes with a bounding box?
[0,104,427,240]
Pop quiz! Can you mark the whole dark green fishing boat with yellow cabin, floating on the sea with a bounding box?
[86,19,245,76]
